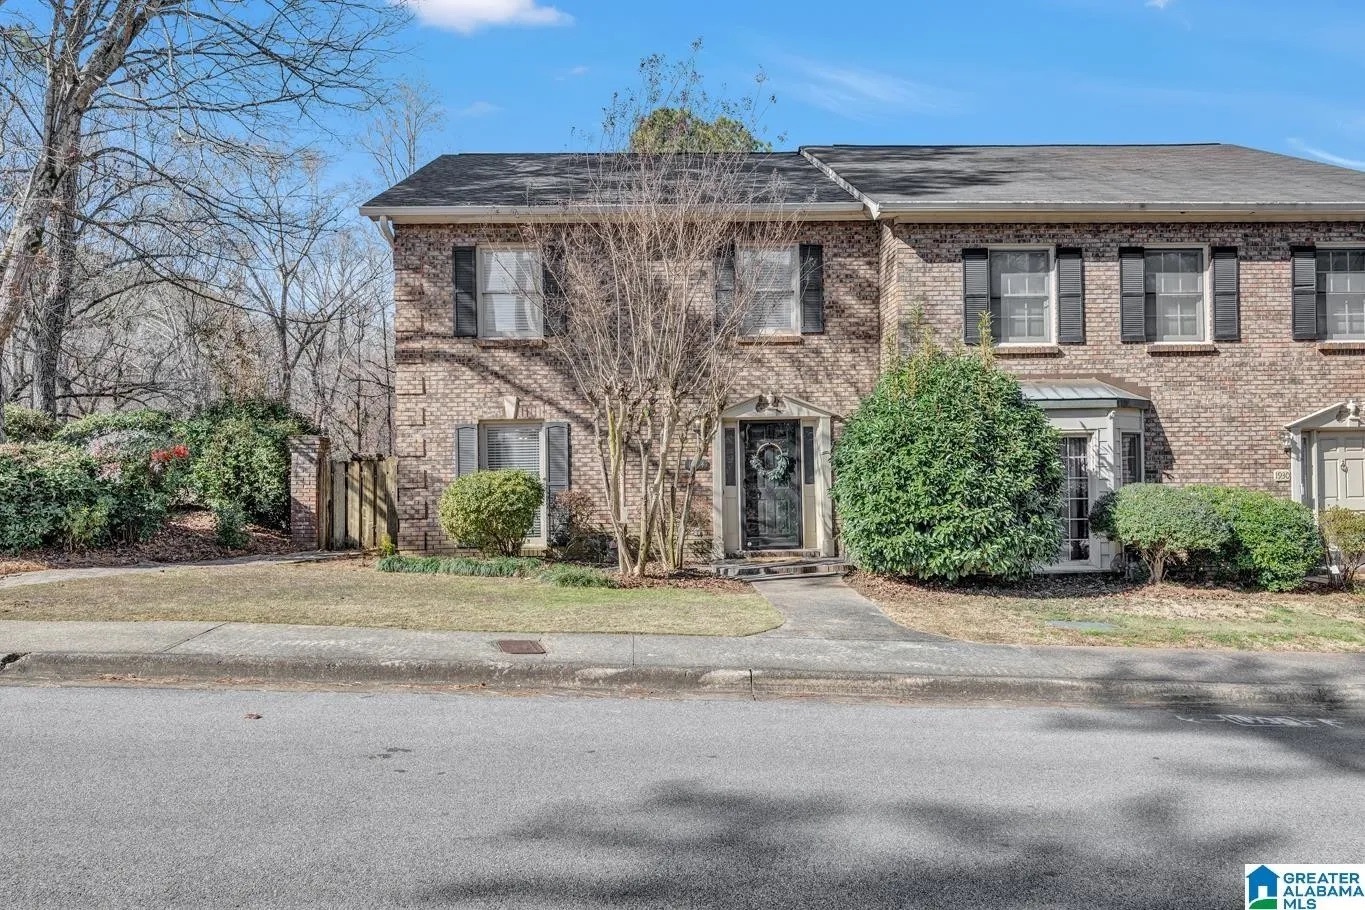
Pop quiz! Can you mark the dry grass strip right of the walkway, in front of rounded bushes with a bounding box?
[849,576,1365,651]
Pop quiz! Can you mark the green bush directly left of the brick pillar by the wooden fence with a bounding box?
[182,401,315,528]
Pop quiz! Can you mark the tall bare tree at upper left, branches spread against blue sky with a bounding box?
[0,0,401,438]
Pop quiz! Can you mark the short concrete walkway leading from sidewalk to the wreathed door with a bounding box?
[752,576,950,641]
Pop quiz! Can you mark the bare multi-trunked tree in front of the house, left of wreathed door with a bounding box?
[527,46,801,576]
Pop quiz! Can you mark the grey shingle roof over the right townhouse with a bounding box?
[804,143,1365,209]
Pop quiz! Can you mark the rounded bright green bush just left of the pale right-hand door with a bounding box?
[1190,486,1324,591]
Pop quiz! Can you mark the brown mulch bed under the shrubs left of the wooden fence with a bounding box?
[0,509,298,576]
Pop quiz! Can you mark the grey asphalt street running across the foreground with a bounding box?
[0,686,1365,910]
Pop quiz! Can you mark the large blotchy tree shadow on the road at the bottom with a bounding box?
[405,782,1279,910]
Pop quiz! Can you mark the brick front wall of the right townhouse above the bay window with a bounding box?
[894,222,1365,495]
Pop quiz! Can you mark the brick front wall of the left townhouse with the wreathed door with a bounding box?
[393,221,882,551]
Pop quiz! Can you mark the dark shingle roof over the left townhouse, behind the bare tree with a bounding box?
[364,151,857,209]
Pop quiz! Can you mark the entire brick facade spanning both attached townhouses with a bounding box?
[393,215,1365,550]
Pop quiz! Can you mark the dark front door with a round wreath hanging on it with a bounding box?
[740,420,801,550]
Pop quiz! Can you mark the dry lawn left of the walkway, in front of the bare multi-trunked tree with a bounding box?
[0,561,782,636]
